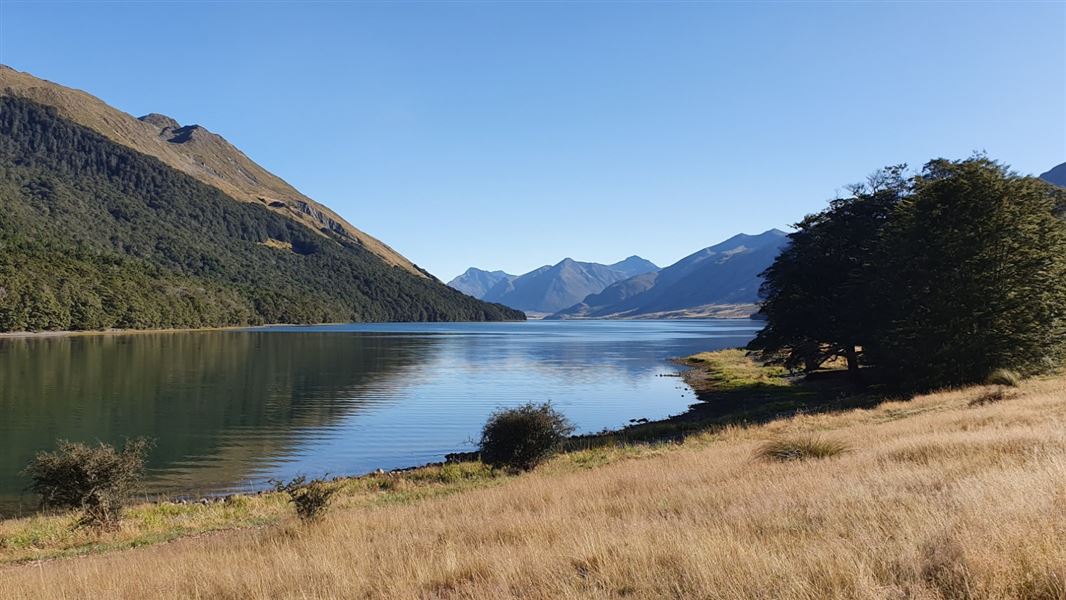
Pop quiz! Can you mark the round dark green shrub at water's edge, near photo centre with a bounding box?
[481,403,574,471]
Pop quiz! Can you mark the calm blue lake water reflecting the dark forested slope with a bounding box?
[0,320,761,515]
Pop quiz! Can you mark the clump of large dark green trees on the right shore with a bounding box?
[749,156,1066,389]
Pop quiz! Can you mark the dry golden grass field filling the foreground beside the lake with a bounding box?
[0,354,1066,599]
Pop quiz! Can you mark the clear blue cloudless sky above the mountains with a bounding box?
[0,0,1066,280]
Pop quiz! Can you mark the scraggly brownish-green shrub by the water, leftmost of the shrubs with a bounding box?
[23,438,151,529]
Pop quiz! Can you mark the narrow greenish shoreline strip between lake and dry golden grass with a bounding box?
[0,348,976,572]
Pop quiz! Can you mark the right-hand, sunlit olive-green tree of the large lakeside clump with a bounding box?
[871,157,1066,387]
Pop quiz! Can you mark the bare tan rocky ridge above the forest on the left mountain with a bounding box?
[0,65,425,276]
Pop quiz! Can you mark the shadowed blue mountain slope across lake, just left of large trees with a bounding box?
[552,229,788,319]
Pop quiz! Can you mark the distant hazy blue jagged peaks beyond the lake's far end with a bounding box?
[448,256,659,313]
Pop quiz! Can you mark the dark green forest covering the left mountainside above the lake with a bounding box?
[0,97,524,331]
